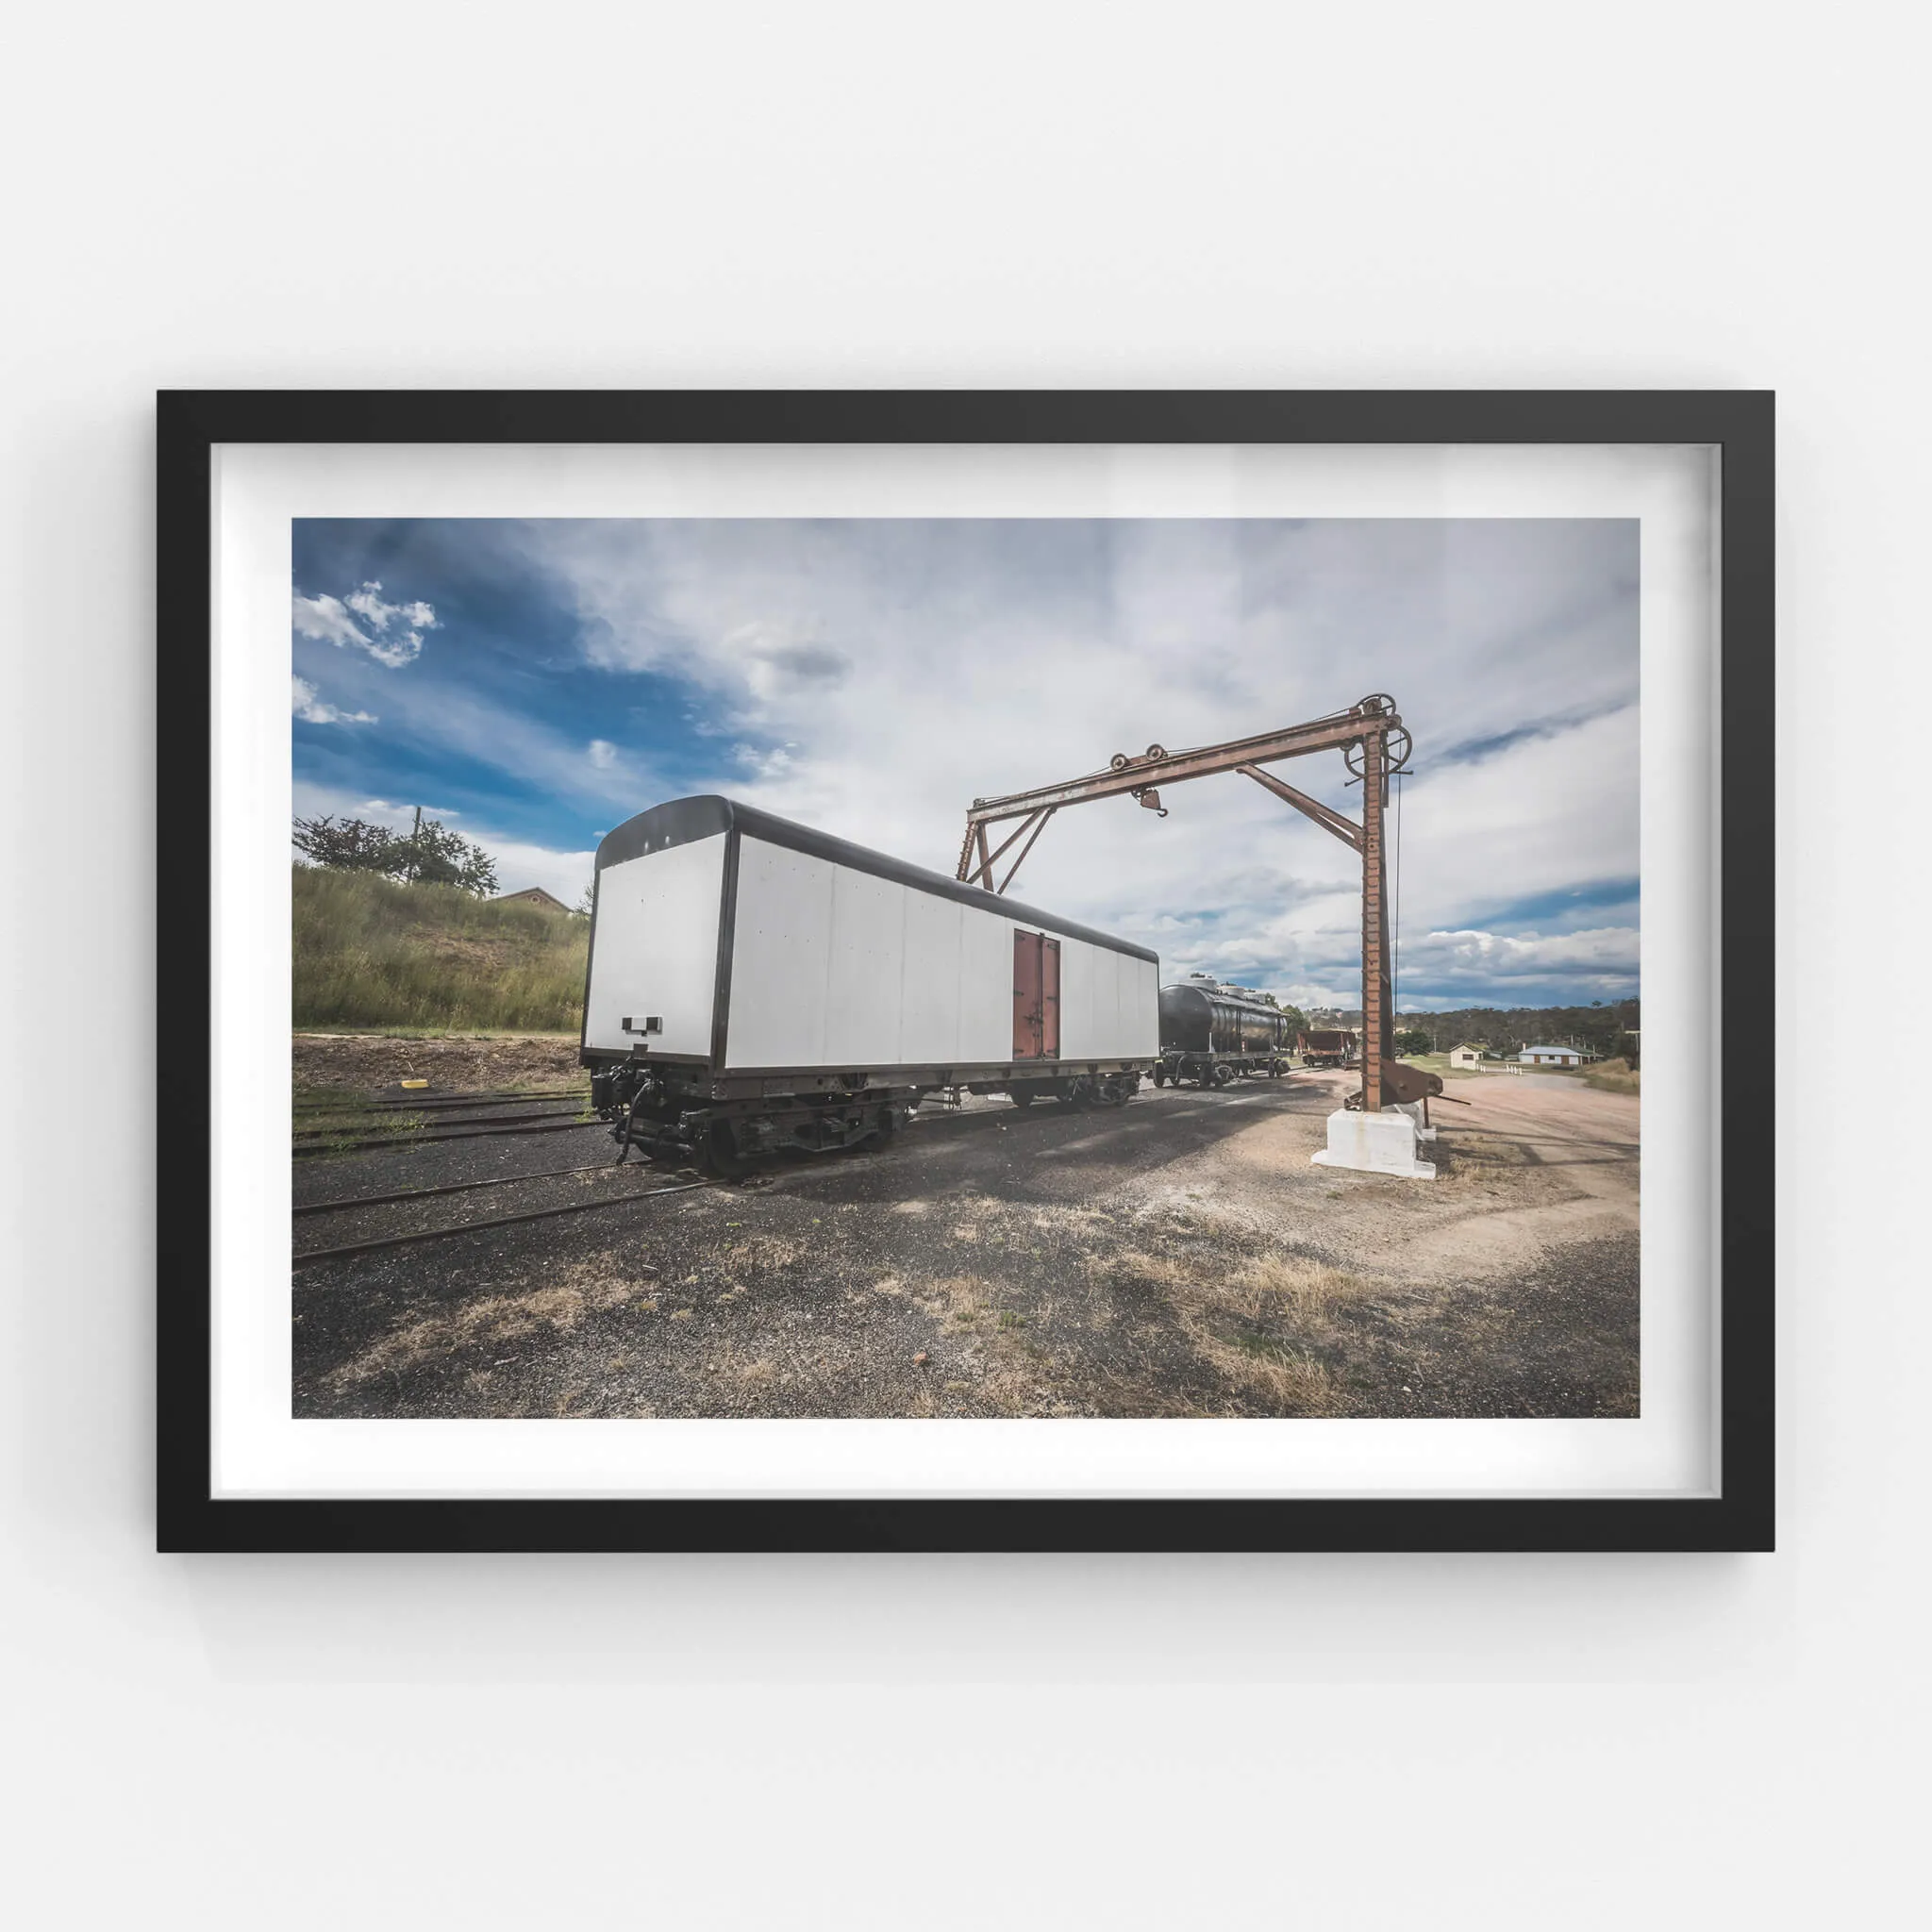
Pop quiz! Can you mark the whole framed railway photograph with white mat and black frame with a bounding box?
[157,391,1775,1549]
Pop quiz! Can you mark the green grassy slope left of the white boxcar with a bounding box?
[293,866,590,1034]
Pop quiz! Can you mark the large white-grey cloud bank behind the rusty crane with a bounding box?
[509,520,1639,1005]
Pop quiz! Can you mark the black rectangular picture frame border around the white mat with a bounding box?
[157,391,1775,1552]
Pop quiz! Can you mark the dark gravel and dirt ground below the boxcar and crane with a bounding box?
[293,1073,1639,1416]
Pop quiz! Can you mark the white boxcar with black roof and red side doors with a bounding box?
[579,798,1159,1173]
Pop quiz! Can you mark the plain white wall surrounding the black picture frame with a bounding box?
[0,0,1932,1932]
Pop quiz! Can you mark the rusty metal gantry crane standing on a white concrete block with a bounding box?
[955,691,1414,1111]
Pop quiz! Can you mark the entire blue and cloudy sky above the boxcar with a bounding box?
[291,520,1639,1010]
